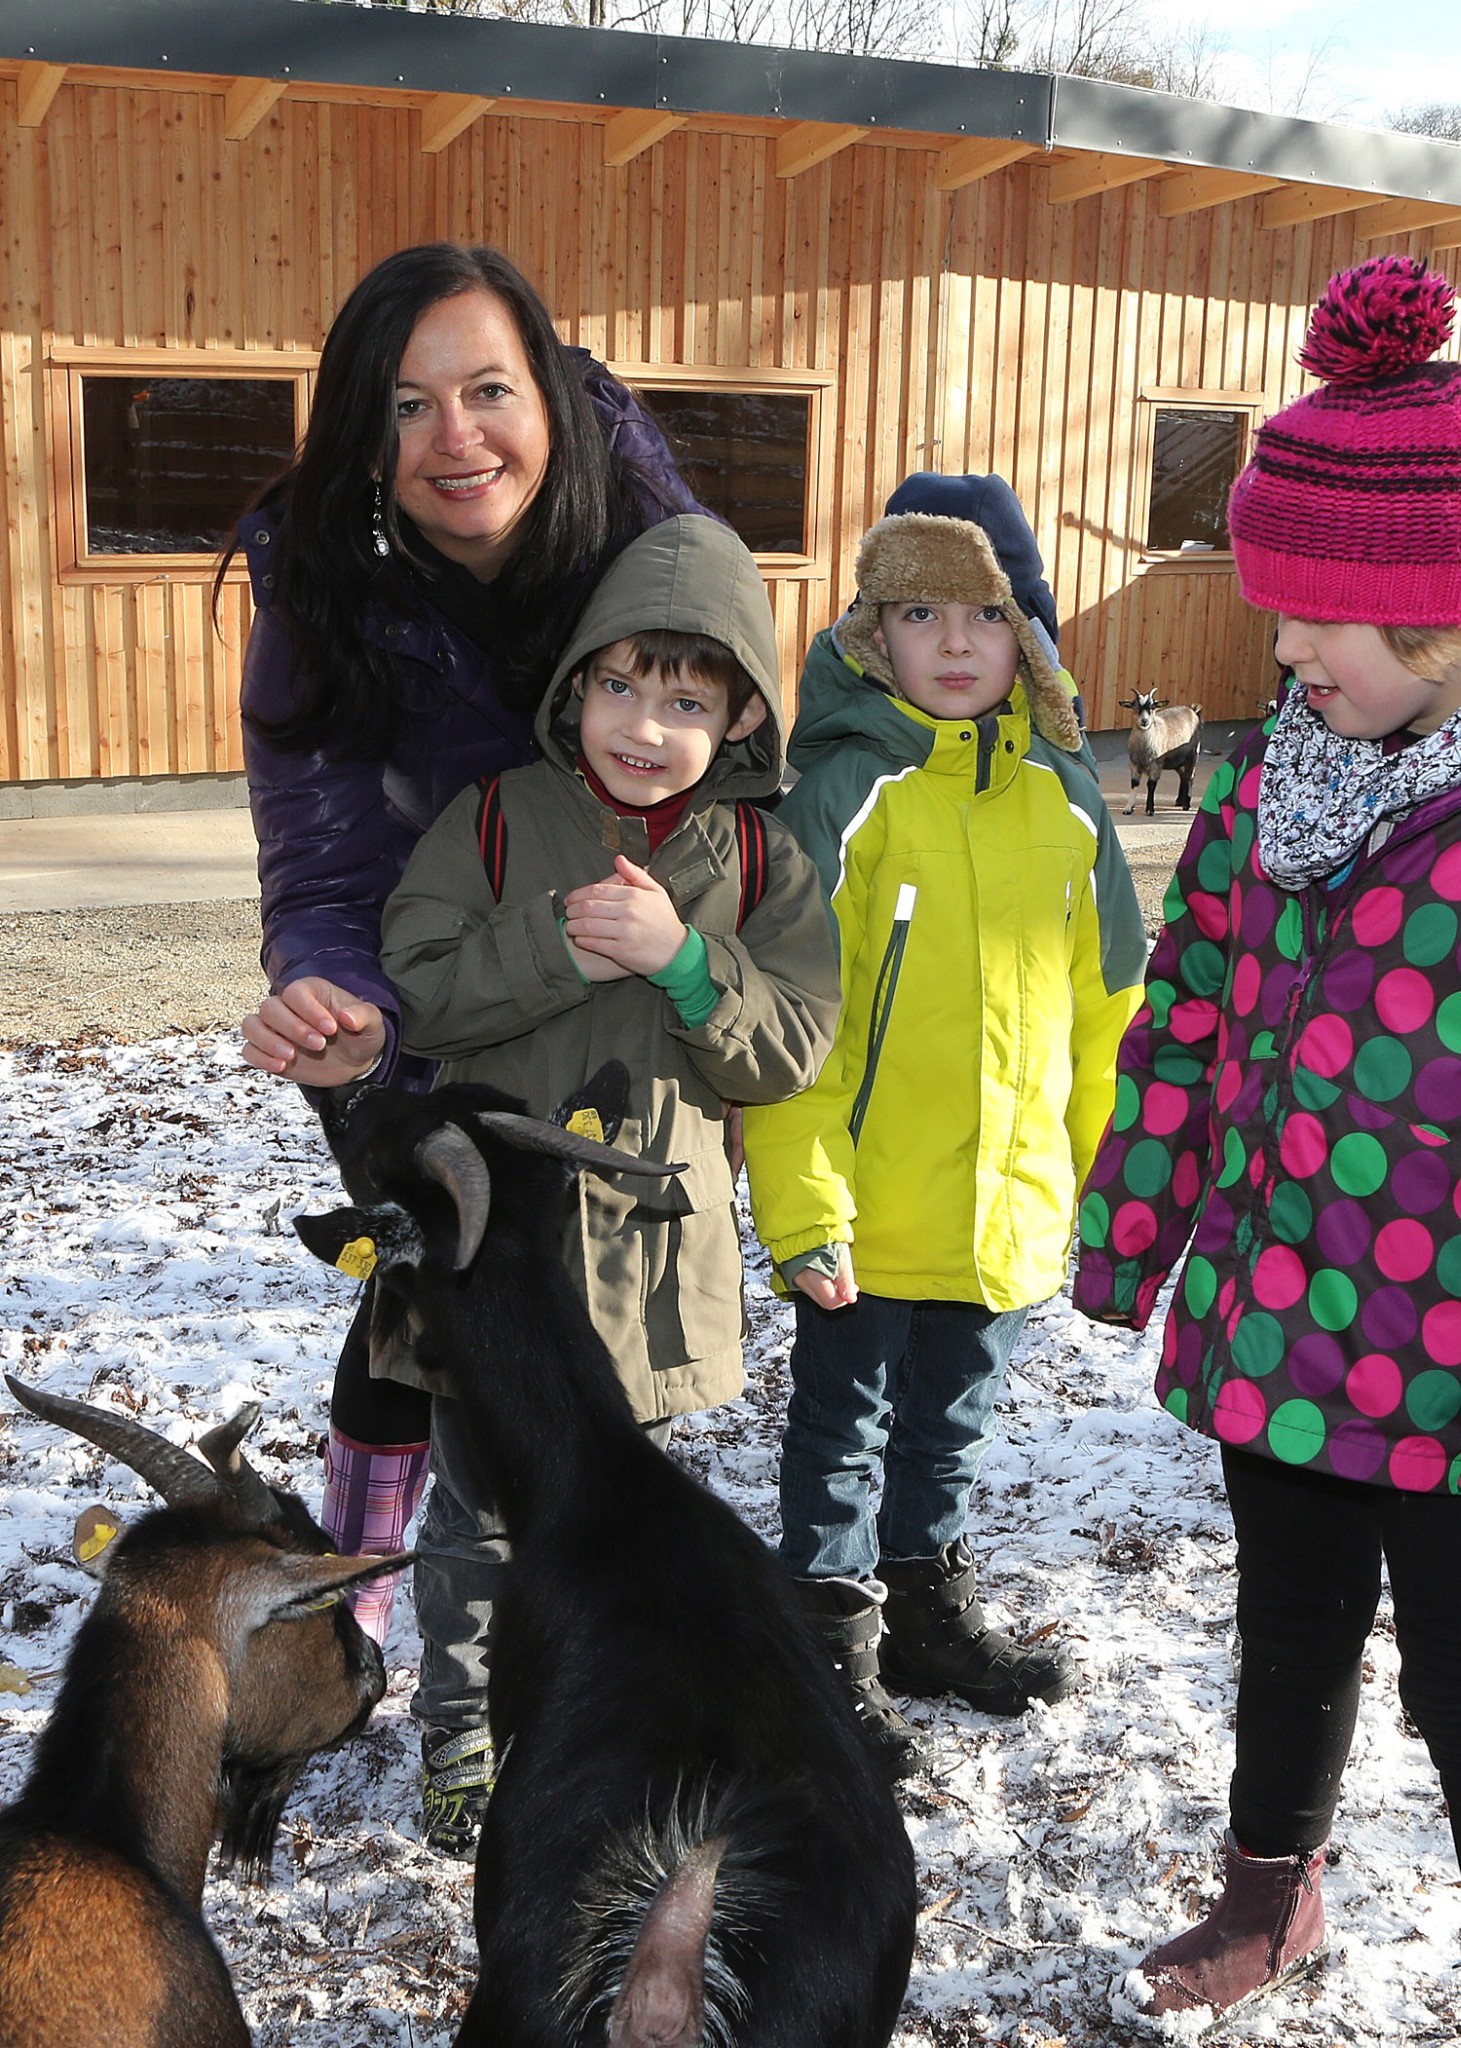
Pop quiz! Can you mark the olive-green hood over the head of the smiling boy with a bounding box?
[537,512,787,799]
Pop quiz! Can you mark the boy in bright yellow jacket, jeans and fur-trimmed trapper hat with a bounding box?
[746,477,1145,1778]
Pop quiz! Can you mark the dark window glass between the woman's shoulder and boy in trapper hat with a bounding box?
[639,387,811,555]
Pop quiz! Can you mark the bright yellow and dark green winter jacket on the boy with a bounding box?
[746,629,1145,1311]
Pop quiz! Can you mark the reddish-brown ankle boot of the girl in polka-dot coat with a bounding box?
[1141,1829,1326,2015]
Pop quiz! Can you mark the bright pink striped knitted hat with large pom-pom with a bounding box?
[1227,256,1461,627]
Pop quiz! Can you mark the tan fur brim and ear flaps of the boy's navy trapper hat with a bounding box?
[836,512,1080,754]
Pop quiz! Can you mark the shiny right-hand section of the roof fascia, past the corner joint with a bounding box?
[1049,78,1461,207]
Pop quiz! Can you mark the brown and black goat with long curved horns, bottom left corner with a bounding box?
[0,1376,410,2048]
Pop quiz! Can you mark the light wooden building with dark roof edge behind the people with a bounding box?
[0,0,1461,782]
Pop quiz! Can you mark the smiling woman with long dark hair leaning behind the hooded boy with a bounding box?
[219,242,701,1859]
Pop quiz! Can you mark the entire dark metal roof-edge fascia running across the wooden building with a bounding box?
[0,0,1461,207]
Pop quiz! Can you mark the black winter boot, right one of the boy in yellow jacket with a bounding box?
[877,1542,1080,1714]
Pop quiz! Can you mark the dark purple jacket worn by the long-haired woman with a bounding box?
[240,348,703,1085]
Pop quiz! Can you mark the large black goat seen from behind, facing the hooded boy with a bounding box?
[295,1069,914,2048]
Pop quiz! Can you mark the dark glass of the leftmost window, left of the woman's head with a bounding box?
[82,375,295,555]
